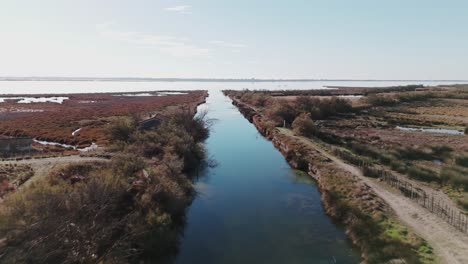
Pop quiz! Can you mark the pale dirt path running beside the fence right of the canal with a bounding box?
[280,129,468,264]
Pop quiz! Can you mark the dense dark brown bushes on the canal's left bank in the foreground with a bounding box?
[0,108,208,263]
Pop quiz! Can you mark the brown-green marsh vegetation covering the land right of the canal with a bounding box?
[225,85,468,263]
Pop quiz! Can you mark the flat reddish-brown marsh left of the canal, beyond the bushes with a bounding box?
[0,91,207,146]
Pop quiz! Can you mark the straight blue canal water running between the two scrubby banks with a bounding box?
[176,92,360,264]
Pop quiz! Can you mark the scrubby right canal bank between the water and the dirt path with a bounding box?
[228,92,434,263]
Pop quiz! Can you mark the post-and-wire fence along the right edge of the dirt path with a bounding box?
[332,148,468,234]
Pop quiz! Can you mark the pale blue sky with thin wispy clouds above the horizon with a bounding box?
[0,0,468,80]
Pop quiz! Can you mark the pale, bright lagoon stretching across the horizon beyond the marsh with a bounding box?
[0,81,467,94]
